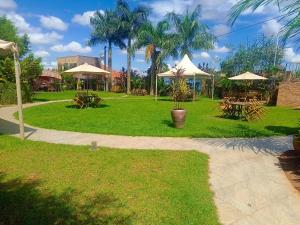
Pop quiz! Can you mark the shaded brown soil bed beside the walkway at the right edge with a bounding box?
[278,150,300,191]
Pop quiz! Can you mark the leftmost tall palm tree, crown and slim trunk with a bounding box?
[88,10,126,90]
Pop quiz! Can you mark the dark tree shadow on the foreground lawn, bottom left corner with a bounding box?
[0,173,133,225]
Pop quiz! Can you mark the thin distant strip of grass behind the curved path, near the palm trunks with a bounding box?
[32,90,149,102]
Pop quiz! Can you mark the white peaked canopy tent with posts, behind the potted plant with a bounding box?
[156,54,213,98]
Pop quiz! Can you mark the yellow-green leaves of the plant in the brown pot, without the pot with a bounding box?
[171,69,192,109]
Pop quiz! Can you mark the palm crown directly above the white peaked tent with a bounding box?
[166,5,215,57]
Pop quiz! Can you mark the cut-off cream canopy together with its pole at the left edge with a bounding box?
[0,40,24,139]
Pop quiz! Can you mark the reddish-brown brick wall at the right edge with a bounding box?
[277,82,300,107]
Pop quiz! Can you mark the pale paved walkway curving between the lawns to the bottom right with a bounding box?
[0,103,300,225]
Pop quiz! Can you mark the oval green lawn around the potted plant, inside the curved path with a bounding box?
[24,98,300,137]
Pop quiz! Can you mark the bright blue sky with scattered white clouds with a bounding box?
[0,0,300,71]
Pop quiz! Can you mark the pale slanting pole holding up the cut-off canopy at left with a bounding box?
[13,45,24,140]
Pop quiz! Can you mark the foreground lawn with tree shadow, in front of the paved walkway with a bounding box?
[0,135,218,225]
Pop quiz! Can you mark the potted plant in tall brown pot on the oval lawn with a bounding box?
[171,69,191,128]
